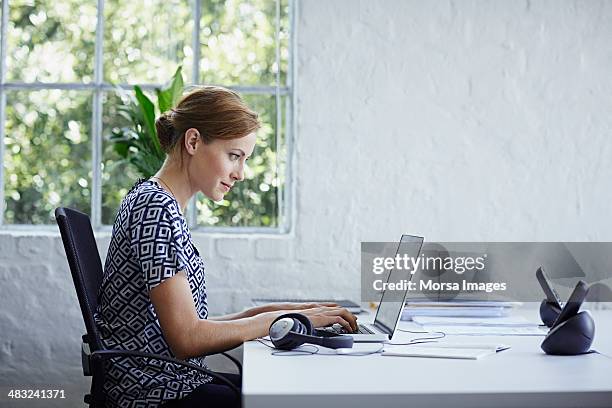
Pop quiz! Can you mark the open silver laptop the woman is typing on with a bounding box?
[319,235,424,343]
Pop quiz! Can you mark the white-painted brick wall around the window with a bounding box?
[0,0,612,406]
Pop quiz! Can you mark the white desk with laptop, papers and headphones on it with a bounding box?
[242,311,612,408]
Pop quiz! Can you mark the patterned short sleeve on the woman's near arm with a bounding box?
[131,200,188,291]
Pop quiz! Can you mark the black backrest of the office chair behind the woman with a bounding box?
[55,207,102,351]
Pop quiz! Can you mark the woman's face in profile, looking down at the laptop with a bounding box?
[189,133,256,201]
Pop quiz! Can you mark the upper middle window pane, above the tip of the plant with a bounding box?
[104,0,193,84]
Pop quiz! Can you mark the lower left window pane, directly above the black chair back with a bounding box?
[3,90,92,224]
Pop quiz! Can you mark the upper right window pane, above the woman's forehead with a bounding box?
[200,0,288,85]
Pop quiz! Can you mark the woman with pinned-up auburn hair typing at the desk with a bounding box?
[96,87,356,407]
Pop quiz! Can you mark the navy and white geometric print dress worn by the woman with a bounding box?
[95,180,212,407]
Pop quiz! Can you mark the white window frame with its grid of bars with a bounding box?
[0,0,299,235]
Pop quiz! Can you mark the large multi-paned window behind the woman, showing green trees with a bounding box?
[0,0,294,232]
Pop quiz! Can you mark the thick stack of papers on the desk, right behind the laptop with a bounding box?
[402,300,521,320]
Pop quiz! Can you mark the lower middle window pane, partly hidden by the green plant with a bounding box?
[102,92,142,225]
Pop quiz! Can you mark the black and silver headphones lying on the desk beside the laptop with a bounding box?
[270,313,353,350]
